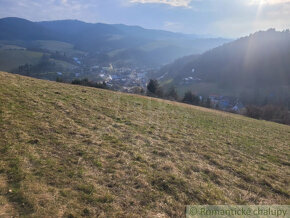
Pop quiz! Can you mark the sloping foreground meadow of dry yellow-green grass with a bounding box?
[0,72,290,217]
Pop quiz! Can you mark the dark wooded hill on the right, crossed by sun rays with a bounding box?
[159,29,290,105]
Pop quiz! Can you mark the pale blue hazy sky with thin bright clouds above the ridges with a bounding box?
[0,0,290,37]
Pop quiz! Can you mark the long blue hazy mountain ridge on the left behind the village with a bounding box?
[0,18,229,66]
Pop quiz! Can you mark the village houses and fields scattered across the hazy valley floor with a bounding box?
[15,48,245,113]
